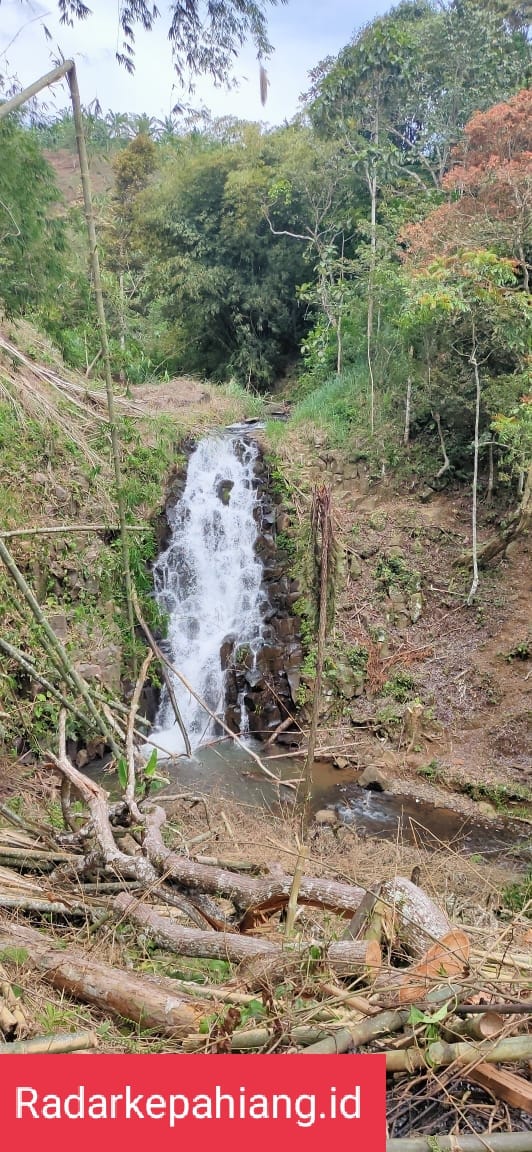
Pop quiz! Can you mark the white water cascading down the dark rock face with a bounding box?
[147,434,264,756]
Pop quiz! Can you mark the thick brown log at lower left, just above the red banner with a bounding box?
[0,916,202,1038]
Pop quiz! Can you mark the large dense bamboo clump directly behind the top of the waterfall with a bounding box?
[138,122,306,387]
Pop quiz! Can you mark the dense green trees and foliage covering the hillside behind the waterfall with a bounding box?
[0,0,532,479]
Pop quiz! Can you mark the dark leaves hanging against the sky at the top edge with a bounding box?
[16,0,286,83]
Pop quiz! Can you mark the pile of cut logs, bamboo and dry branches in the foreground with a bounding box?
[0,741,532,1150]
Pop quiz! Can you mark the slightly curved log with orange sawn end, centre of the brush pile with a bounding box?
[113,893,381,988]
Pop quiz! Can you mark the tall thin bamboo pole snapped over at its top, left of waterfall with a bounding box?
[0,60,137,675]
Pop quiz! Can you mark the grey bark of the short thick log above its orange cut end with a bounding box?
[379,877,451,960]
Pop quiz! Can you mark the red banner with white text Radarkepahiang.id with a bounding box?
[0,1054,386,1152]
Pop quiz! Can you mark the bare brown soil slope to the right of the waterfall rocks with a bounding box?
[274,428,532,817]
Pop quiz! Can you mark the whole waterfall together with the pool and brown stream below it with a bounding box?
[135,427,527,855]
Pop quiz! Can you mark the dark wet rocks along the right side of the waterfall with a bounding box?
[221,444,303,743]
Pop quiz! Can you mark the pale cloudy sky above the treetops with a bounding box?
[0,0,392,124]
